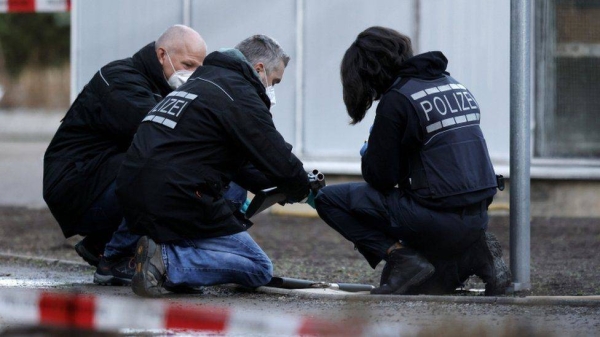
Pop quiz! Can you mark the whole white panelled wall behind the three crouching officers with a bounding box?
[72,0,510,174]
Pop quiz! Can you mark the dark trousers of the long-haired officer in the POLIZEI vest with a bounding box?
[315,183,488,268]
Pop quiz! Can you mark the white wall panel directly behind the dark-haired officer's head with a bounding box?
[304,0,415,158]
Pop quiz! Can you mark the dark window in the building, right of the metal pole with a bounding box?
[534,0,600,159]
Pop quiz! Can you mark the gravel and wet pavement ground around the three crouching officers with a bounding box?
[0,207,600,337]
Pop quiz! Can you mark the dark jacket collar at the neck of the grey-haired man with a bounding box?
[202,51,271,109]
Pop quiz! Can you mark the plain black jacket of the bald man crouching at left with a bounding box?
[43,43,171,237]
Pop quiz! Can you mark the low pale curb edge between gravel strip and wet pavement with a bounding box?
[0,252,600,308]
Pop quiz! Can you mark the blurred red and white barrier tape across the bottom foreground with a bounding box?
[0,289,400,336]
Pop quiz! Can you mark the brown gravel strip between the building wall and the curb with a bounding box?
[0,207,600,296]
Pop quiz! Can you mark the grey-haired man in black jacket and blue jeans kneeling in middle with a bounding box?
[117,35,312,297]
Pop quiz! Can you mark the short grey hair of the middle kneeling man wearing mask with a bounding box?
[235,35,290,71]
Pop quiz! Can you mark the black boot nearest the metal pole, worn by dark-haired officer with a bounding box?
[458,232,512,296]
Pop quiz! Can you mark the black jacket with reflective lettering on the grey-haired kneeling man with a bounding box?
[117,52,309,242]
